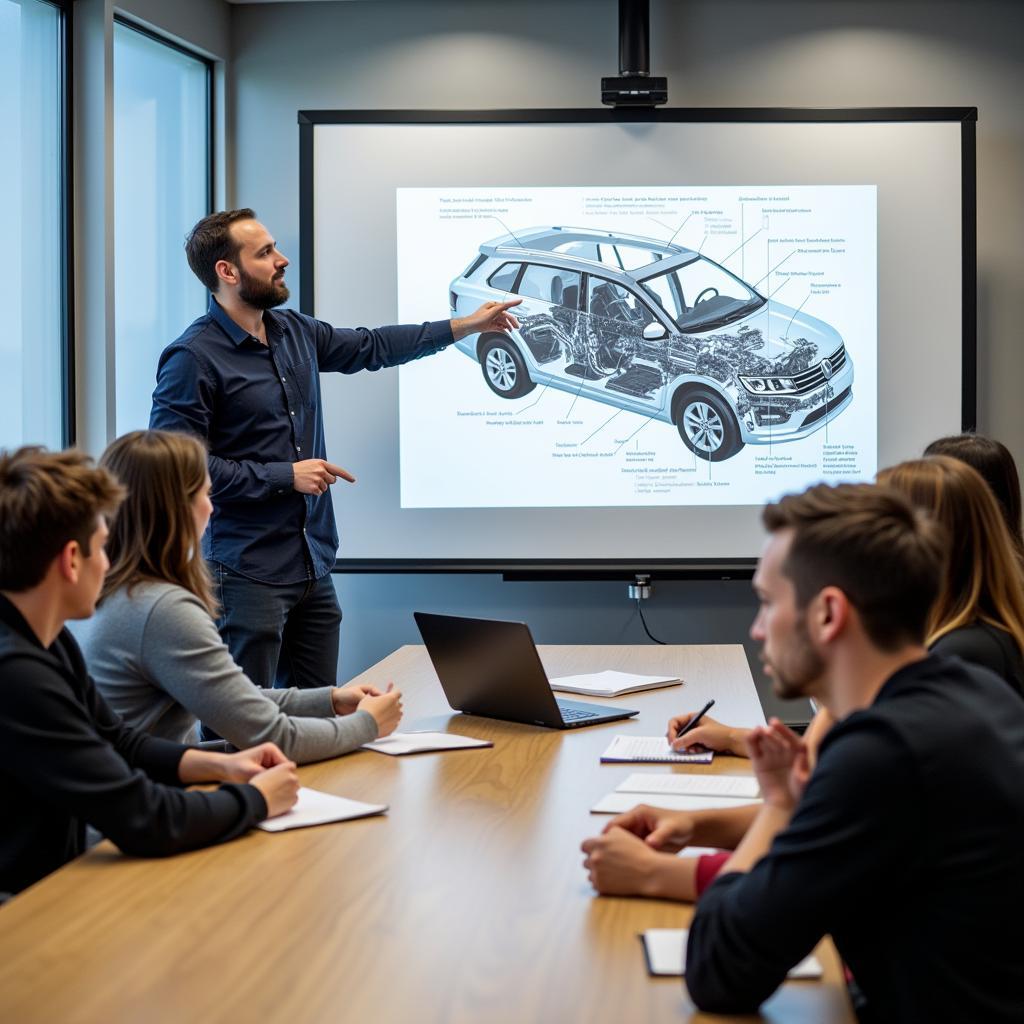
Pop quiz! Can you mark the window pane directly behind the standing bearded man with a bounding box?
[114,22,211,434]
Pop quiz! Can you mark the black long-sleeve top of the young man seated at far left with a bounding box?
[0,596,266,892]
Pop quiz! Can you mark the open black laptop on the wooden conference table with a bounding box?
[413,611,639,729]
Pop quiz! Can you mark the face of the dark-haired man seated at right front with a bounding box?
[751,530,825,700]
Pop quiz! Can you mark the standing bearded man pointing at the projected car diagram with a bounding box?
[150,209,519,686]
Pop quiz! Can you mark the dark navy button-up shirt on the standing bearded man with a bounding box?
[150,297,453,584]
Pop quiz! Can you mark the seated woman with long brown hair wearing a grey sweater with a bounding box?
[76,430,401,763]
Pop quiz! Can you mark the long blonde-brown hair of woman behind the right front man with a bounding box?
[878,455,1024,651]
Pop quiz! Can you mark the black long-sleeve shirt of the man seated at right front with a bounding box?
[686,655,1024,1024]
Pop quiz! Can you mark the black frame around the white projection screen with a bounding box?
[298,106,978,581]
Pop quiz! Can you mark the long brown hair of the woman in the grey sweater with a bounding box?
[99,430,217,615]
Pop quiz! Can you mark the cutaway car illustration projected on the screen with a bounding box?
[450,227,853,462]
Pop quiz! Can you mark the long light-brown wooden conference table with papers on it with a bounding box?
[0,645,853,1024]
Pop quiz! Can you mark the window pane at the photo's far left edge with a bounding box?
[0,0,72,449]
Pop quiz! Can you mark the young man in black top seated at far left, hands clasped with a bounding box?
[0,447,298,892]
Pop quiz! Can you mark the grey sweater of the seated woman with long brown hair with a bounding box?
[70,583,377,763]
